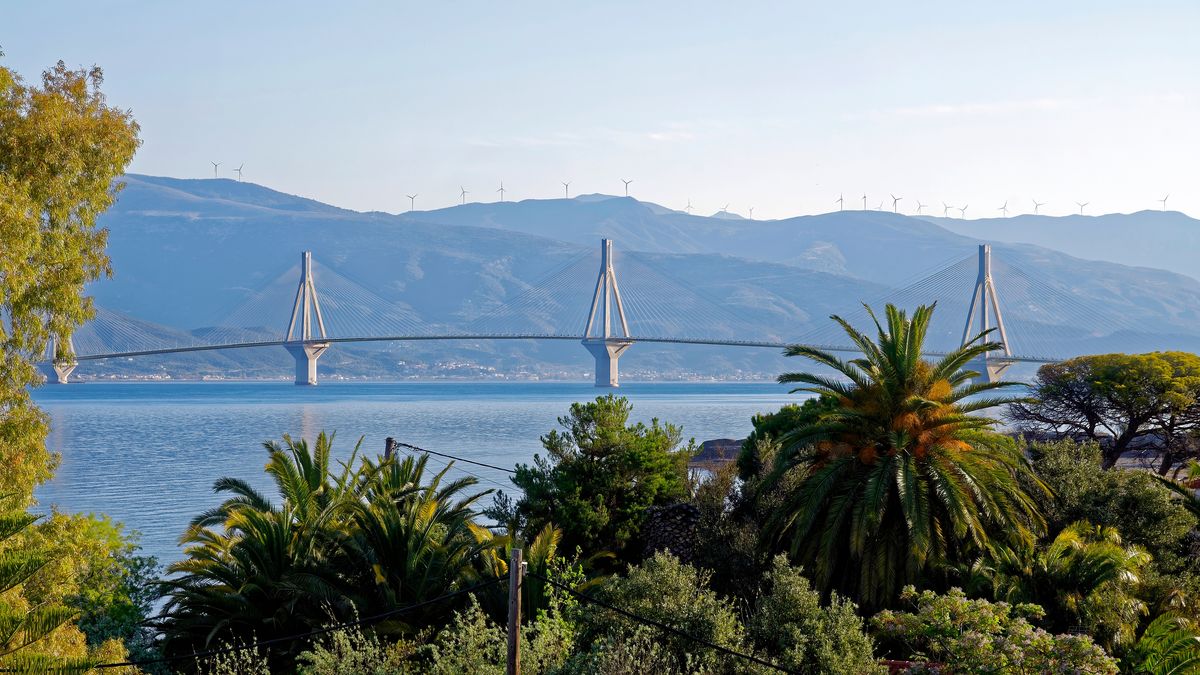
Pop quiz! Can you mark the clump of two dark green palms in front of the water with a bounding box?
[160,434,491,669]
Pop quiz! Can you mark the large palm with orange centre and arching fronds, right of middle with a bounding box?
[767,305,1045,608]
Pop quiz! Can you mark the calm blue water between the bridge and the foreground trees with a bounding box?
[34,383,796,562]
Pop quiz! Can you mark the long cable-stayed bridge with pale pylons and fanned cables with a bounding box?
[43,239,1128,387]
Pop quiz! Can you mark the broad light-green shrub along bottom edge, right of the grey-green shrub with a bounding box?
[871,586,1117,674]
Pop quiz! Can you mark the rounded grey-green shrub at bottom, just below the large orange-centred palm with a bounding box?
[746,556,886,675]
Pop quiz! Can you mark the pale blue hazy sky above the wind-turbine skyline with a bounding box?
[0,0,1200,217]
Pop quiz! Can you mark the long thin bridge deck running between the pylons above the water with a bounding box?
[65,334,1061,363]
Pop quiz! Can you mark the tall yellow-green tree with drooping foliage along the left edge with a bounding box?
[0,53,139,500]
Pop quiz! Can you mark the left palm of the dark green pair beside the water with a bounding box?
[158,434,358,659]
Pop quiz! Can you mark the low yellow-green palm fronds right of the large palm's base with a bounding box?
[976,521,1151,651]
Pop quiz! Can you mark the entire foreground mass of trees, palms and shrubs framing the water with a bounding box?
[9,49,1200,674]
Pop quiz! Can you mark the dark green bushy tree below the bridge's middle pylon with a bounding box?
[501,394,695,560]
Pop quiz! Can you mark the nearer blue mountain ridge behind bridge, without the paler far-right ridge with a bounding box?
[82,175,1200,376]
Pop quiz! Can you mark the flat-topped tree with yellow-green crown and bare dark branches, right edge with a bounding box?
[1008,352,1200,474]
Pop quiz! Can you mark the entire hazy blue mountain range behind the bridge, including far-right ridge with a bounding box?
[72,174,1200,378]
